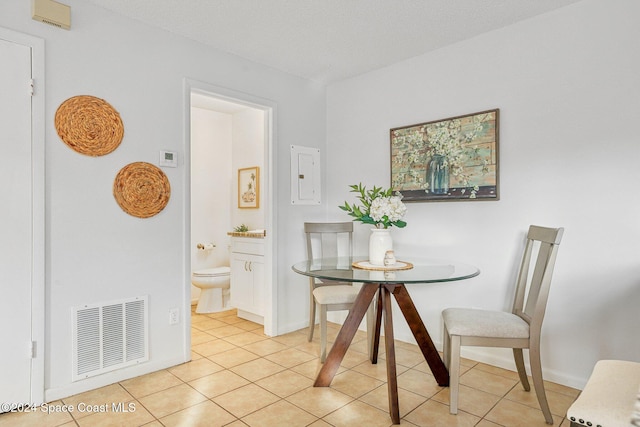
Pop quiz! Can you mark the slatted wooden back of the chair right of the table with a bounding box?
[512,225,564,335]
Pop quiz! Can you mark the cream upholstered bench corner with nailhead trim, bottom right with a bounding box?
[567,360,640,427]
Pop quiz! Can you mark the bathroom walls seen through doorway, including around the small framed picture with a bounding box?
[191,108,265,303]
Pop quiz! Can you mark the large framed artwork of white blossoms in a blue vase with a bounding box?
[390,109,500,202]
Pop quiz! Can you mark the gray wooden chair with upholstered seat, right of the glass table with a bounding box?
[442,225,564,424]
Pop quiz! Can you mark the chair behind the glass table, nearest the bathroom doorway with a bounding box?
[304,222,359,363]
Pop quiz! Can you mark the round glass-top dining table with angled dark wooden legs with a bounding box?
[292,257,480,424]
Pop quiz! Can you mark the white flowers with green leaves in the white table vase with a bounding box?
[338,184,407,228]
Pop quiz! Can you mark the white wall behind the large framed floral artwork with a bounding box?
[326,0,640,386]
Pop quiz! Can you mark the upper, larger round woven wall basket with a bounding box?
[54,95,124,157]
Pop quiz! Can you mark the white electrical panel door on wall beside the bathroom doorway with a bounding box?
[291,145,321,205]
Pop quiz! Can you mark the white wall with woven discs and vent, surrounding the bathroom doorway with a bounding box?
[0,0,326,400]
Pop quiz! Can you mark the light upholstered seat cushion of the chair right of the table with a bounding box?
[442,308,529,338]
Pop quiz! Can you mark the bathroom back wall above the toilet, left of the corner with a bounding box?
[190,108,233,301]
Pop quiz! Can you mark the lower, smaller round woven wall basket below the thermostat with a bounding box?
[113,162,171,218]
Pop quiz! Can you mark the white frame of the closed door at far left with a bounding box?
[0,27,46,405]
